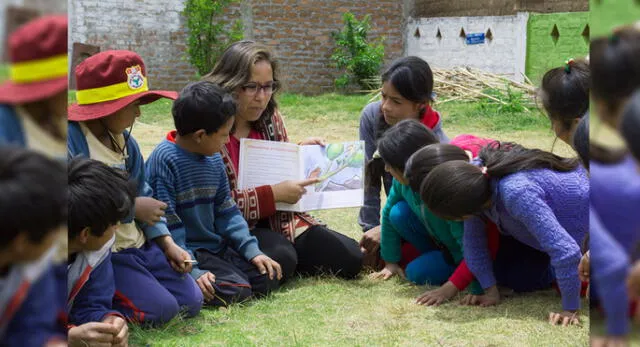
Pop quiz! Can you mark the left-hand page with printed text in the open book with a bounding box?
[238,139,302,212]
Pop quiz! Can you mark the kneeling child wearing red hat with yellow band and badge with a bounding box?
[68,51,202,325]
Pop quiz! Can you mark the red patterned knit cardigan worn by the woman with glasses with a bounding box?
[221,110,323,242]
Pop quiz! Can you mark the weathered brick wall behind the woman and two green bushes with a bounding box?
[70,0,406,94]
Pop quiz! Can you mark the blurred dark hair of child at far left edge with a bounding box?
[0,146,67,248]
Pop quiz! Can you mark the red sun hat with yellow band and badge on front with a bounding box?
[68,51,178,122]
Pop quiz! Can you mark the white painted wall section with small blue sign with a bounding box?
[405,12,529,81]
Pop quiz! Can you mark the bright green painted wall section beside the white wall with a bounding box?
[526,12,590,84]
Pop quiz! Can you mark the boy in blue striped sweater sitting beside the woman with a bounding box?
[146,82,282,306]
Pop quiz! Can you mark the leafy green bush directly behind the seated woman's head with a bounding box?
[182,0,243,76]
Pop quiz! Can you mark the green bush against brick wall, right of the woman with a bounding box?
[331,12,384,90]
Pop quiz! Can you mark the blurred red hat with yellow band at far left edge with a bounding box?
[0,15,69,105]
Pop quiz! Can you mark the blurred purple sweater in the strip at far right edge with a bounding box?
[590,156,640,335]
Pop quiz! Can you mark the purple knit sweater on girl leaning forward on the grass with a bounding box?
[463,167,589,310]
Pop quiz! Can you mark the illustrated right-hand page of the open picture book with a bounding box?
[301,141,364,211]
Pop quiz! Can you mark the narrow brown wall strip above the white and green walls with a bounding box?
[412,0,588,17]
